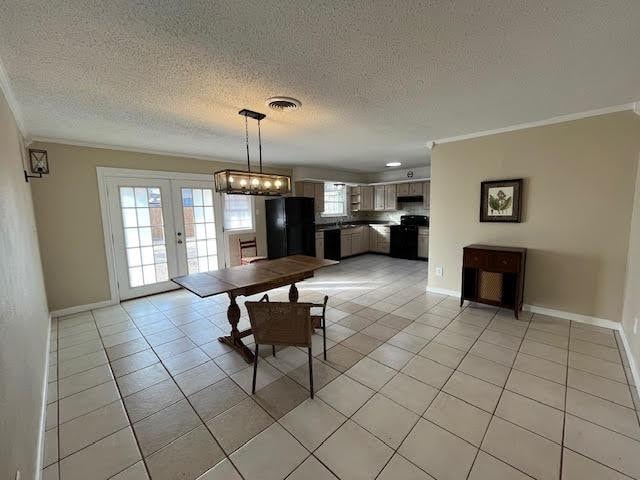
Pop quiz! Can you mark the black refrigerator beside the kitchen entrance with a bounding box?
[265,197,316,259]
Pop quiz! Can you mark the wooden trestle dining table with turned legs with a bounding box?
[171,255,338,363]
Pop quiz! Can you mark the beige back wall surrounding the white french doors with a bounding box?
[28,143,290,311]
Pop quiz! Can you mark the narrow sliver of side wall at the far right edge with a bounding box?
[622,156,640,376]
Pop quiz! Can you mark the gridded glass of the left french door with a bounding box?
[120,187,169,288]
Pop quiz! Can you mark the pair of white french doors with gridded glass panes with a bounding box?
[105,176,225,300]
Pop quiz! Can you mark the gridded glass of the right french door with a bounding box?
[182,188,218,273]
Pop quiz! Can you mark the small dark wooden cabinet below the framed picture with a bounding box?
[460,245,527,318]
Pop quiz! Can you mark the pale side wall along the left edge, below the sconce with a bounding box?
[0,91,49,479]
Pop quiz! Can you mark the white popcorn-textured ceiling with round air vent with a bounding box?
[0,0,640,171]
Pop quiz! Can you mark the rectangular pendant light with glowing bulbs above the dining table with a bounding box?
[213,108,291,197]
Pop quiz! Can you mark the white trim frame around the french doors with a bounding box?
[96,167,222,303]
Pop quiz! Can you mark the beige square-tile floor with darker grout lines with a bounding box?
[43,255,640,480]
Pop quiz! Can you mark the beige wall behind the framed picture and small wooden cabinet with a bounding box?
[429,111,640,322]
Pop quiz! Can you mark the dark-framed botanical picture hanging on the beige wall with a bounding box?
[480,178,522,222]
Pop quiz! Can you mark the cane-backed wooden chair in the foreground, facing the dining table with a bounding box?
[245,295,326,398]
